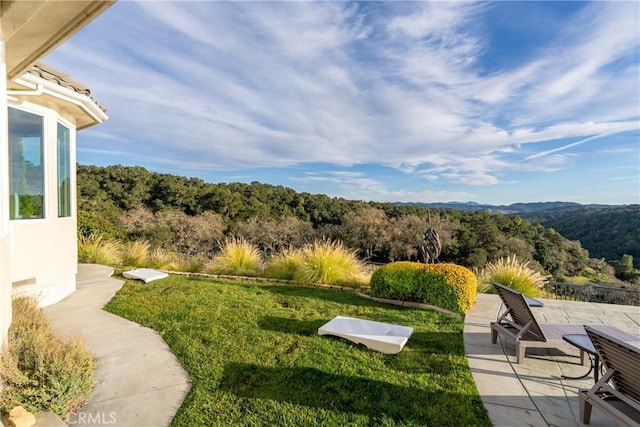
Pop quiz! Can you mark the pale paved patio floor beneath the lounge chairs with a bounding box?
[464,294,640,427]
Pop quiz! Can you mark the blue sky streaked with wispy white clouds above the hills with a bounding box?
[45,0,640,204]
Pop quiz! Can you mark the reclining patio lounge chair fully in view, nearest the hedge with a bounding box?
[491,283,586,364]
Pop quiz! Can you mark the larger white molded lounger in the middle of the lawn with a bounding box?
[318,316,413,354]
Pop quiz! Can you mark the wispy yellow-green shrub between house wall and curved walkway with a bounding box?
[0,297,95,418]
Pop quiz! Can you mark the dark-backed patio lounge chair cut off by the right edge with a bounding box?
[578,326,640,426]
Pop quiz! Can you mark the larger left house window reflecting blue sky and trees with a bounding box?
[9,108,44,219]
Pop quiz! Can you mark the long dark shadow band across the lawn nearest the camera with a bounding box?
[220,363,482,425]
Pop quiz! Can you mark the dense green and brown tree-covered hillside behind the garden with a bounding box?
[78,165,636,283]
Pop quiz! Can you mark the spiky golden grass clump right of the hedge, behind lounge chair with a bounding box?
[478,255,547,297]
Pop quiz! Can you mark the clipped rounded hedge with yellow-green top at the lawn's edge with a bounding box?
[371,261,477,314]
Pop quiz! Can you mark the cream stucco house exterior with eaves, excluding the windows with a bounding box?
[0,0,115,347]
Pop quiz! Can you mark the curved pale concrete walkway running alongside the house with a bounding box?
[43,264,191,426]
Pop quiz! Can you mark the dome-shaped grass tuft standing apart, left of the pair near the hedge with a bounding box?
[211,238,264,276]
